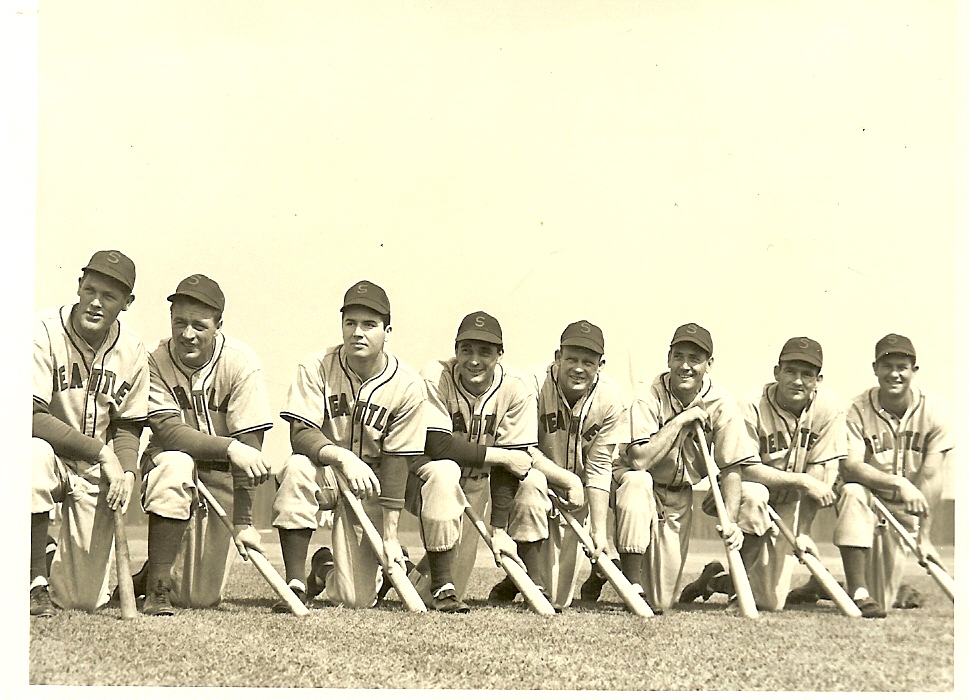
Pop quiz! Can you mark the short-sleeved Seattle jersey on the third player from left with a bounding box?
[280,345,428,467]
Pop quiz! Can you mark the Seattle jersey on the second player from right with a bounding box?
[741,382,847,474]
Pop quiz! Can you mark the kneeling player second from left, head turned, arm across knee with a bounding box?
[125,274,272,615]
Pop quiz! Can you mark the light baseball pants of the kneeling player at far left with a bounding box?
[30,438,114,612]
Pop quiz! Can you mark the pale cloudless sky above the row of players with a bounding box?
[3,0,966,696]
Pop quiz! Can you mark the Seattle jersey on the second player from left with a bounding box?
[148,333,273,460]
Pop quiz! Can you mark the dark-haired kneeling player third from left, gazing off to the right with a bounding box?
[273,280,427,612]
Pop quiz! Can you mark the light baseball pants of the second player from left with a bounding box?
[141,452,236,608]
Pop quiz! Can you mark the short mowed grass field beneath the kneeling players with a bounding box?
[29,532,954,692]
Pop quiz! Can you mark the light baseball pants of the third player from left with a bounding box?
[273,455,384,608]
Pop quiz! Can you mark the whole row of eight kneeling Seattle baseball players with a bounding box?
[30,251,953,617]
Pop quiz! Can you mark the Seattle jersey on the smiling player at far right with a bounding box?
[845,387,955,480]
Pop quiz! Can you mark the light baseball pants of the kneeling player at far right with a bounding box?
[834,484,918,610]
